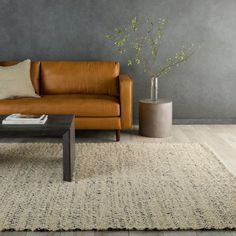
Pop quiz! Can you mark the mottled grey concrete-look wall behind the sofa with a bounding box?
[0,0,236,120]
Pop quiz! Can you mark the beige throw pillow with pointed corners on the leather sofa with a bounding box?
[0,59,39,99]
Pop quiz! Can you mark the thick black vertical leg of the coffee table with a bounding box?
[63,124,75,182]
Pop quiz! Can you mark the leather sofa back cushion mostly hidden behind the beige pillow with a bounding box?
[0,61,40,94]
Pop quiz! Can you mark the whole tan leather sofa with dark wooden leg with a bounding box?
[0,61,132,140]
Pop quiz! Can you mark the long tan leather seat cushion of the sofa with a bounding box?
[0,94,120,117]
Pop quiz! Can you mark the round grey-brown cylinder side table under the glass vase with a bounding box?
[139,99,172,138]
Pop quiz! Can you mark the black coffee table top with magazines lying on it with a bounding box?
[0,115,74,137]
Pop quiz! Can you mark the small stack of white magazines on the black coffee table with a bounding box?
[2,114,48,125]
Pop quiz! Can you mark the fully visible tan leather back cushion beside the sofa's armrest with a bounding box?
[41,61,119,96]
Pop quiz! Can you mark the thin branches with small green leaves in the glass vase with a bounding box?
[106,17,194,77]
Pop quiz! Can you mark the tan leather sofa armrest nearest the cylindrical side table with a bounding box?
[119,75,133,129]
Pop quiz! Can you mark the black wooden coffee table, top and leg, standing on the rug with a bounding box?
[0,115,75,182]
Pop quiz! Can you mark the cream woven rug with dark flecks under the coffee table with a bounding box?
[0,143,236,231]
